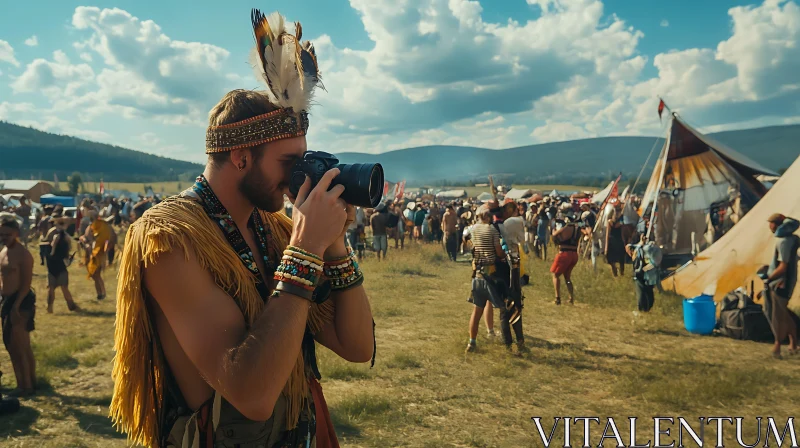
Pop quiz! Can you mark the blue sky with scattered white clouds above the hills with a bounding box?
[0,0,800,161]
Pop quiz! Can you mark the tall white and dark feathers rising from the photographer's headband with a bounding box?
[250,9,320,113]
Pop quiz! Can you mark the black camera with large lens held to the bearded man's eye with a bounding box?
[289,151,383,208]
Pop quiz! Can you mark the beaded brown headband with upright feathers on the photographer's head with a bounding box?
[206,9,321,154]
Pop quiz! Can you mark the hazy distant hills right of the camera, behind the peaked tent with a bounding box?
[338,125,800,186]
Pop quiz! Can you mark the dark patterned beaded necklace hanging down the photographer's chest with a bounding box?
[192,174,279,300]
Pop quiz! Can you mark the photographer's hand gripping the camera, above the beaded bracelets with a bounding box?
[289,168,348,256]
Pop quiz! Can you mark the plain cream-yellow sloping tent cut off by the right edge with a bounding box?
[662,158,800,309]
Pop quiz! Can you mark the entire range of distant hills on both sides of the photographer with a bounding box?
[0,122,800,185]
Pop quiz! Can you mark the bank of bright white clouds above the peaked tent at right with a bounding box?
[534,0,800,138]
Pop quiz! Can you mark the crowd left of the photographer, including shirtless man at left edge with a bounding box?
[0,192,144,400]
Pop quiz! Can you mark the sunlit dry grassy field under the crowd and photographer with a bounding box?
[0,240,800,448]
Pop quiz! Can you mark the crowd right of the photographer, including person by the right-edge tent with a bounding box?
[340,189,800,357]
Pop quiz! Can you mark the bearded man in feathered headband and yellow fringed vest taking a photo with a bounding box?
[111,10,375,448]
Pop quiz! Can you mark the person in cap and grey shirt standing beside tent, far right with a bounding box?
[759,213,800,359]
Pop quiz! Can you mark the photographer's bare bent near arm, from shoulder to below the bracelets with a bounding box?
[144,251,310,421]
